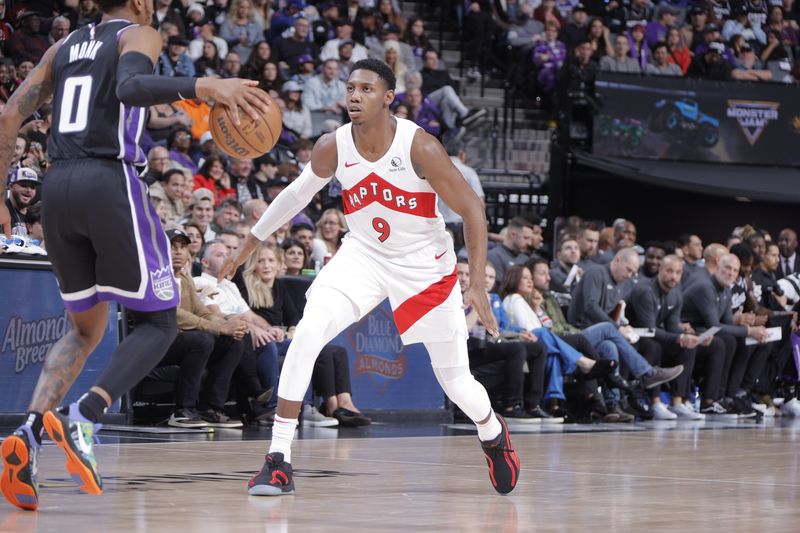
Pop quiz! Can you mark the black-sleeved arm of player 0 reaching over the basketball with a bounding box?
[116,26,270,125]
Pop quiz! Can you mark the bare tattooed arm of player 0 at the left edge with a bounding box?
[0,39,63,237]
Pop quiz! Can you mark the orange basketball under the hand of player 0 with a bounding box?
[209,90,282,159]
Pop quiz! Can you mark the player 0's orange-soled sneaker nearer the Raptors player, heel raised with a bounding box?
[44,403,103,495]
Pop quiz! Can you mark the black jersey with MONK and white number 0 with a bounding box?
[47,20,147,165]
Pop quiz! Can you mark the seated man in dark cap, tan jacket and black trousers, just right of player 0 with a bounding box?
[160,229,247,428]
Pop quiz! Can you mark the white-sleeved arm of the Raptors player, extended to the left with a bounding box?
[218,133,337,280]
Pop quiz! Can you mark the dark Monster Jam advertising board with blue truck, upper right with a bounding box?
[592,73,800,166]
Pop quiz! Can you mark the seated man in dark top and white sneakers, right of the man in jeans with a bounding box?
[626,255,708,420]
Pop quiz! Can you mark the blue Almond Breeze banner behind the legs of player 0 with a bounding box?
[0,269,119,413]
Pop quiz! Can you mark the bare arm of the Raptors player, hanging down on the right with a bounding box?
[411,129,498,336]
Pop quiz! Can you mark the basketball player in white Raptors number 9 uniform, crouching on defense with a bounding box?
[221,59,520,496]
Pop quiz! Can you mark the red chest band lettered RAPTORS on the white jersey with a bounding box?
[342,172,436,218]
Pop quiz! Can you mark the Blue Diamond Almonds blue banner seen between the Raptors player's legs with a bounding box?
[331,300,444,410]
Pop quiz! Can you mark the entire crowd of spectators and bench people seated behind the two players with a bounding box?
[0,0,800,427]
